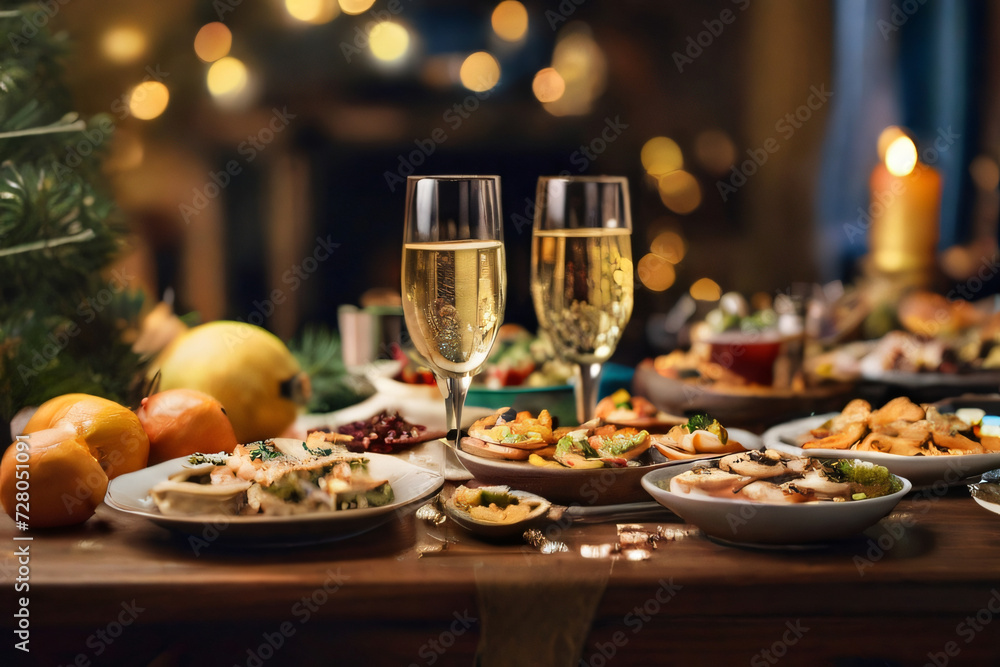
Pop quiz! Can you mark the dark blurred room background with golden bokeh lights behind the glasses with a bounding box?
[53,0,1000,363]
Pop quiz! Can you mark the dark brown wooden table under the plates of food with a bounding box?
[0,487,1000,667]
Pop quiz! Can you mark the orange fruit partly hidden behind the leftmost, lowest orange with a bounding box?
[24,394,149,479]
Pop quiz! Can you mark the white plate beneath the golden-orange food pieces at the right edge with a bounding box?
[763,412,1000,487]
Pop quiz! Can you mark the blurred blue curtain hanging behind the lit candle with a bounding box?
[816,0,985,279]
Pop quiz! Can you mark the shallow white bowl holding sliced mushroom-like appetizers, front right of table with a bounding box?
[642,463,911,545]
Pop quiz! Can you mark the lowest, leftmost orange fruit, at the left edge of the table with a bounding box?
[0,423,108,528]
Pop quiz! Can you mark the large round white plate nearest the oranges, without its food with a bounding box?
[104,454,444,546]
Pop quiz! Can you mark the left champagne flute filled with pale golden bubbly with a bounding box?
[403,176,507,445]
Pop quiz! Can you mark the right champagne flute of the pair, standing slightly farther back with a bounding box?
[531,176,633,424]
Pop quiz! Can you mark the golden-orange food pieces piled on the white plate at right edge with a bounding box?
[799,397,1000,456]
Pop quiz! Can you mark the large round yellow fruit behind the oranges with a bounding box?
[149,320,309,443]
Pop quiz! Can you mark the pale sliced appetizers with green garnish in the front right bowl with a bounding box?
[667,449,903,504]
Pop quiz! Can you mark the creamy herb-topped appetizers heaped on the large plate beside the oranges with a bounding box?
[150,432,393,516]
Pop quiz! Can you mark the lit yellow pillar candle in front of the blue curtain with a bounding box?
[868,133,941,273]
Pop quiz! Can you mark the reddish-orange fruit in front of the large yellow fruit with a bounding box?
[136,389,238,465]
